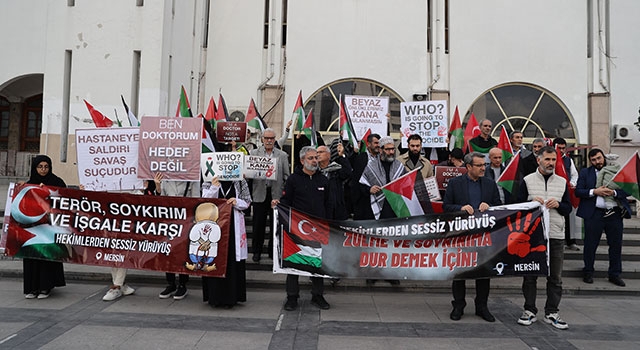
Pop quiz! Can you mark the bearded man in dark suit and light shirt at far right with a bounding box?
[576,148,631,287]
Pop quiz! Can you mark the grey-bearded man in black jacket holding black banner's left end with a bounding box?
[271,146,333,311]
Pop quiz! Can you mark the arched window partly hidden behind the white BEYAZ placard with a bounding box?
[304,78,404,138]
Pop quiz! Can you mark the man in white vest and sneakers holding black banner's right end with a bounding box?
[509,146,571,329]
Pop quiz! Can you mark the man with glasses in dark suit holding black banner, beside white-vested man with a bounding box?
[443,152,501,322]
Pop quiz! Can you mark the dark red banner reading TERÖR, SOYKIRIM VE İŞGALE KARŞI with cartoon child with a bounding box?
[5,185,235,277]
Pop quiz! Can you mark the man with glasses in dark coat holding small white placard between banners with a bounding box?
[250,128,289,262]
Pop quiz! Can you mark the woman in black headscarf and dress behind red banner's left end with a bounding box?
[22,155,67,299]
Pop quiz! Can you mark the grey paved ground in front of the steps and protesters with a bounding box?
[0,276,640,350]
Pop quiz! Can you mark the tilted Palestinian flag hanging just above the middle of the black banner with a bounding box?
[382,169,433,218]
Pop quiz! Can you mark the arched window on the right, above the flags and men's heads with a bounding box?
[465,83,577,145]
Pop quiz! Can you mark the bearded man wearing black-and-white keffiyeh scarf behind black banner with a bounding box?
[360,136,406,285]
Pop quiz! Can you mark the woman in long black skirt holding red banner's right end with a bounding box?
[202,176,251,309]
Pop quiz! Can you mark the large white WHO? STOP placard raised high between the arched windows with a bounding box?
[400,101,449,148]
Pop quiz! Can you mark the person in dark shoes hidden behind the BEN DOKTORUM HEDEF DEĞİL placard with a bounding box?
[158,180,200,300]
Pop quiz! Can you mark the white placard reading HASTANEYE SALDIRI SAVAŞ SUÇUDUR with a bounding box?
[76,128,142,191]
